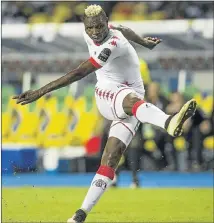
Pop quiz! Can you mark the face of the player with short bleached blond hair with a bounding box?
[84,15,109,43]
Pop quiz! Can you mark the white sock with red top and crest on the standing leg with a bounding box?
[81,166,114,213]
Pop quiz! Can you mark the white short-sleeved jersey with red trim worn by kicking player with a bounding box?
[83,29,144,93]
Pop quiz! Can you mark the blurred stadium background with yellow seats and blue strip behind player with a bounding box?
[1,1,214,220]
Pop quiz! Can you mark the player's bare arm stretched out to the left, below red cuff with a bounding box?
[13,60,97,105]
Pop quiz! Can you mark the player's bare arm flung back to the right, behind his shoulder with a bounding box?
[111,25,162,50]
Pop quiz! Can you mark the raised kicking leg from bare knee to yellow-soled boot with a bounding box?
[123,93,196,137]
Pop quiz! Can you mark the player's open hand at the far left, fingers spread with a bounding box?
[13,90,42,105]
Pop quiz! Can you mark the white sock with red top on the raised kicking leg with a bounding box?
[132,100,169,129]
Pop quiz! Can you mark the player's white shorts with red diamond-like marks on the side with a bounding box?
[95,82,144,146]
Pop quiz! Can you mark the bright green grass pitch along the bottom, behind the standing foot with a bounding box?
[2,187,213,223]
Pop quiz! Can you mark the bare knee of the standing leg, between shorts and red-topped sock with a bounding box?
[101,138,126,169]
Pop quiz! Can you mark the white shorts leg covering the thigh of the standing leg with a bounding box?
[109,116,140,147]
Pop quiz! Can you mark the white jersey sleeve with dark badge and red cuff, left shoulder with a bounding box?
[89,39,125,68]
